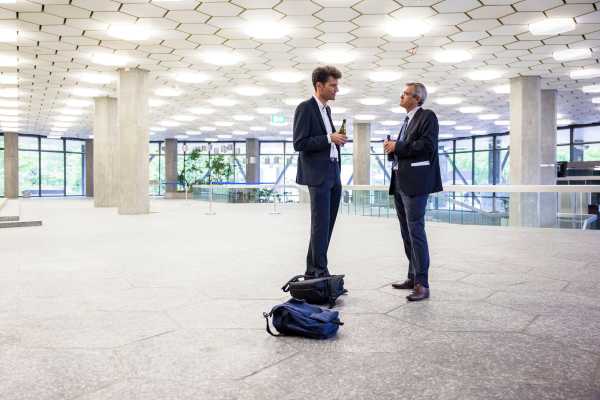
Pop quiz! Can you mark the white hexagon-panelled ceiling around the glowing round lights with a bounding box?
[0,0,600,139]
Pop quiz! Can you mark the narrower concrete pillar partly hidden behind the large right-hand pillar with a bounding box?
[539,89,558,227]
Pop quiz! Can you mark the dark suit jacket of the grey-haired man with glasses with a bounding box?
[390,109,443,196]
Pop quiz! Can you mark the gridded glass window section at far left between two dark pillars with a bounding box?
[19,136,85,196]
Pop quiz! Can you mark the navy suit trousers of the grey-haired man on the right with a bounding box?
[394,190,429,287]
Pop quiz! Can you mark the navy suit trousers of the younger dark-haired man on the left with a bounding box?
[305,161,342,277]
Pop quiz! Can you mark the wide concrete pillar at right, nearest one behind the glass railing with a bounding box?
[509,76,542,226]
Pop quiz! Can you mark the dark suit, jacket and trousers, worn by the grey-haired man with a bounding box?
[389,109,442,287]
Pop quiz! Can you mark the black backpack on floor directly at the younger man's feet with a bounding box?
[281,275,348,308]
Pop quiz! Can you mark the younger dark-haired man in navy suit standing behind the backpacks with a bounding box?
[294,66,346,279]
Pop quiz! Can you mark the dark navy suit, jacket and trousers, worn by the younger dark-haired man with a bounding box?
[294,97,342,277]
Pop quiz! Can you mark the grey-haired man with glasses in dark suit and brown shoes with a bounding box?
[384,83,442,301]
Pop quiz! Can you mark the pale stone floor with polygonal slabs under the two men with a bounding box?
[0,199,600,400]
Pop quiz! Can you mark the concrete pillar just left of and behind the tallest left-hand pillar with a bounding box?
[92,97,119,207]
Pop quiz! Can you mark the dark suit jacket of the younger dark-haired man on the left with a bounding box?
[294,97,341,186]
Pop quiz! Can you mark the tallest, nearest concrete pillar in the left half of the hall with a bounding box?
[118,68,150,214]
